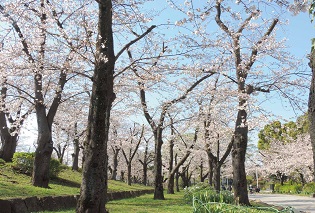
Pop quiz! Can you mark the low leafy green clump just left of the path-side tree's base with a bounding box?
[184,183,234,204]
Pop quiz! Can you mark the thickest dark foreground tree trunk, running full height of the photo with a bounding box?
[76,0,115,213]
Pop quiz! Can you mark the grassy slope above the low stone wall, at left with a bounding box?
[0,164,152,199]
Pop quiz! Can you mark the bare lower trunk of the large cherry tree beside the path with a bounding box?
[232,109,250,205]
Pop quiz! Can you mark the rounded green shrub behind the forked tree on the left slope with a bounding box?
[12,152,63,178]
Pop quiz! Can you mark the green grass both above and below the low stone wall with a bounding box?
[0,163,292,213]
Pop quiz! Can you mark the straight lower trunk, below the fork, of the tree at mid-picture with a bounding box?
[154,133,164,200]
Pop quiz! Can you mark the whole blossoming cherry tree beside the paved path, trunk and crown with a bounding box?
[170,0,305,205]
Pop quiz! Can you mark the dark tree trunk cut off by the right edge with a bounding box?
[308,50,315,182]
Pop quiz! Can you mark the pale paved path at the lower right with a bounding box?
[249,194,315,213]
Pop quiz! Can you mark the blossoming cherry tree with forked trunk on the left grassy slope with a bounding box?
[0,0,92,187]
